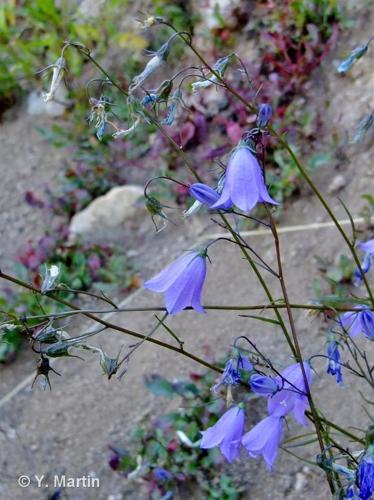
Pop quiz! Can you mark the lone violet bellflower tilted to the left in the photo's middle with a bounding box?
[144,250,206,314]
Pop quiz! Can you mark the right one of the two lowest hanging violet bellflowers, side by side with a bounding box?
[242,416,283,470]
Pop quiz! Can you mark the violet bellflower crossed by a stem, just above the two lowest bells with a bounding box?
[268,361,312,426]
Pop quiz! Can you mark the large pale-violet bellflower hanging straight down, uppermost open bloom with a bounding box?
[210,143,278,212]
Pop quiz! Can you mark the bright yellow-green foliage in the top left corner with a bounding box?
[0,0,137,113]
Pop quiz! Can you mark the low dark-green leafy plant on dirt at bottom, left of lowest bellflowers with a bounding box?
[109,373,241,500]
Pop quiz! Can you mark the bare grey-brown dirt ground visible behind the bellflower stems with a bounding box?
[0,1,374,500]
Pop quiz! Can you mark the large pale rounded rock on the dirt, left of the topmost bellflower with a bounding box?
[70,185,146,239]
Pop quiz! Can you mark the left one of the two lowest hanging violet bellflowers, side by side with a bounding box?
[200,406,245,463]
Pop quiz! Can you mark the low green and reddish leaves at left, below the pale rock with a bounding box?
[0,232,139,363]
